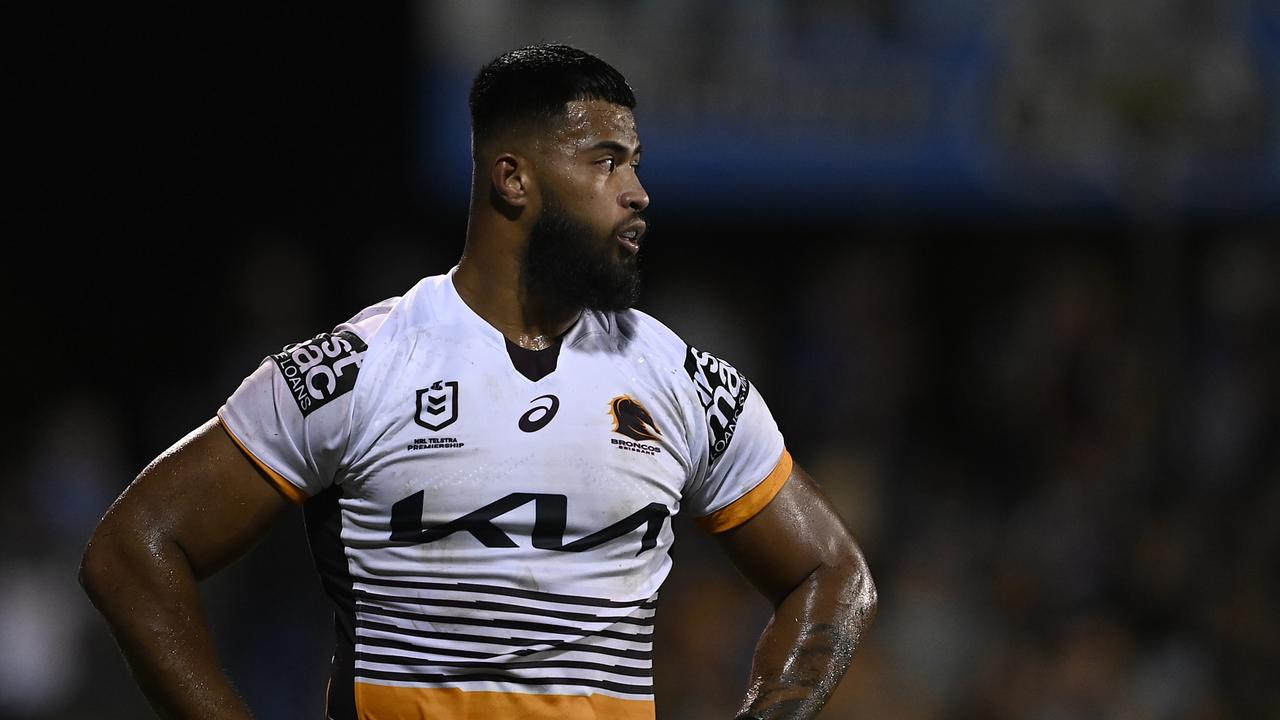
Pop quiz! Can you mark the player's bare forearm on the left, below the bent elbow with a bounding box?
[81,527,251,720]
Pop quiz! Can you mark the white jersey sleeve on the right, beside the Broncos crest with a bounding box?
[684,347,791,533]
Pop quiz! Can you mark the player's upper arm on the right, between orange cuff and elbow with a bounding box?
[718,456,860,605]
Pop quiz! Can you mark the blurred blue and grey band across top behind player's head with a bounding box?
[419,0,1280,213]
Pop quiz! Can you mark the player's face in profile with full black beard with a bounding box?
[522,100,649,310]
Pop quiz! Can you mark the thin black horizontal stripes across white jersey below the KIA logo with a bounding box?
[352,577,657,700]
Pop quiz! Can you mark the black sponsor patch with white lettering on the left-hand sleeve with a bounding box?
[271,331,369,418]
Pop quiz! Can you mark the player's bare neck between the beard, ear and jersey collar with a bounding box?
[453,232,582,350]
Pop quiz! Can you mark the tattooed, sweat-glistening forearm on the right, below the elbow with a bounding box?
[739,559,876,720]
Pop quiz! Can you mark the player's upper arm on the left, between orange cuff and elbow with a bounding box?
[93,419,288,579]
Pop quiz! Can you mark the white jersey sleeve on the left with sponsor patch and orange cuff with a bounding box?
[218,325,367,503]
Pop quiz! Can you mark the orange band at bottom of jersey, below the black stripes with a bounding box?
[356,683,654,720]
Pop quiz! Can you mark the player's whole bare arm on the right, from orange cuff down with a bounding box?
[719,465,876,720]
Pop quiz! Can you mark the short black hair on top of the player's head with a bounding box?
[470,44,636,145]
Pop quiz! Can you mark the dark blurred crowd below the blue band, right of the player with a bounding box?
[650,225,1280,720]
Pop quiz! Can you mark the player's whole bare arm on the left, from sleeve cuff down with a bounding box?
[79,420,287,720]
